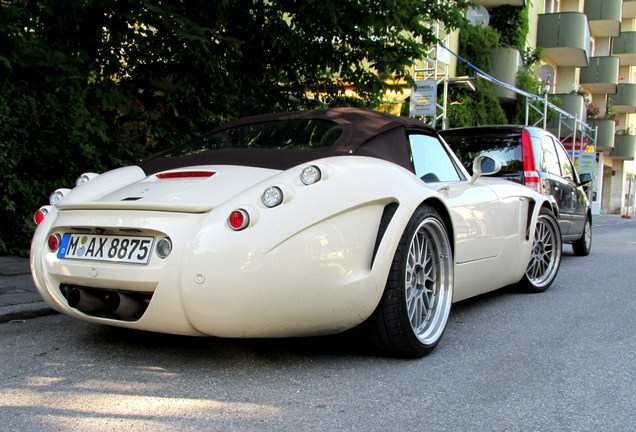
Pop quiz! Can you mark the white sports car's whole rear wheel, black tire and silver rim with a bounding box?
[367,206,453,358]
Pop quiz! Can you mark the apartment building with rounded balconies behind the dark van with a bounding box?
[438,0,636,215]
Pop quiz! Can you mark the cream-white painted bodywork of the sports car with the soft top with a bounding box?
[31,156,540,337]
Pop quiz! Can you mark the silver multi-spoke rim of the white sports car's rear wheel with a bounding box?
[404,217,453,345]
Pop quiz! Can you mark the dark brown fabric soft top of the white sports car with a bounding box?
[140,108,433,175]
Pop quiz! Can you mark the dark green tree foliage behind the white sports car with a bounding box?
[0,0,466,253]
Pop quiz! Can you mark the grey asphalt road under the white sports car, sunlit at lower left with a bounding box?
[0,223,636,432]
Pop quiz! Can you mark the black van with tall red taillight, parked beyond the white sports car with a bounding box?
[440,126,592,256]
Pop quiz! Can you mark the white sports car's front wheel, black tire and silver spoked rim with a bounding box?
[519,208,562,292]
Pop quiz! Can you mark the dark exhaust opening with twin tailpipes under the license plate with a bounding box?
[63,287,148,321]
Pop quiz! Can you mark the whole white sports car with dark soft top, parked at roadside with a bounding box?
[31,108,561,357]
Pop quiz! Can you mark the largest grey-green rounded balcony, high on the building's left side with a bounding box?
[537,12,590,67]
